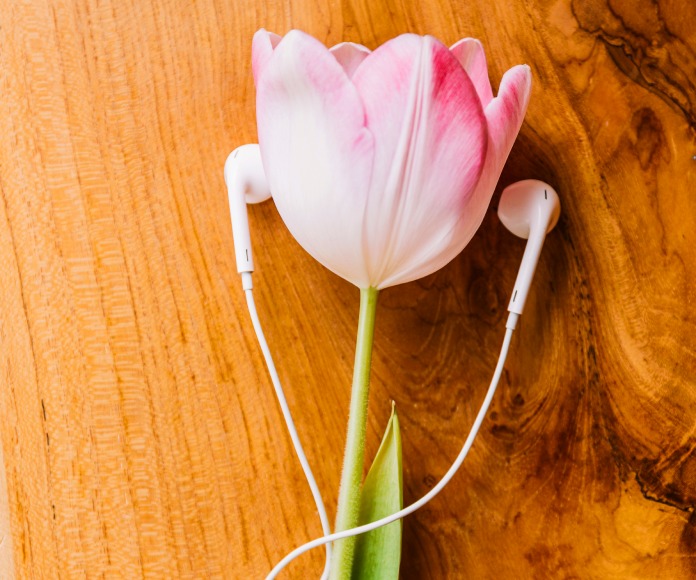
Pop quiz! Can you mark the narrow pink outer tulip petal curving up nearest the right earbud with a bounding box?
[382,65,532,287]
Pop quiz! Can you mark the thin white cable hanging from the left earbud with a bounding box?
[242,272,331,580]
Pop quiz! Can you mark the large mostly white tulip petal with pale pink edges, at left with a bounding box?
[253,30,374,287]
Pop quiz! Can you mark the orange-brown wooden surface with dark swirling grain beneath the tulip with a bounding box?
[0,0,696,579]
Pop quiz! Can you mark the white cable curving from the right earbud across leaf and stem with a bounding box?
[266,328,514,580]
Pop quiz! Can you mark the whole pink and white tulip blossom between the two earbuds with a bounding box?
[252,30,531,289]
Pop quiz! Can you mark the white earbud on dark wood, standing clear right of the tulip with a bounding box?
[498,179,561,328]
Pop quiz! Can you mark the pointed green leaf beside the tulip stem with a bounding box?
[351,403,404,580]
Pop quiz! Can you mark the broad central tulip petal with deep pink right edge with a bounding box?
[353,34,487,288]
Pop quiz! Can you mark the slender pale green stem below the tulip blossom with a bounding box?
[330,288,379,580]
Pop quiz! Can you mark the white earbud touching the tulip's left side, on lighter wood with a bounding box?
[225,144,271,278]
